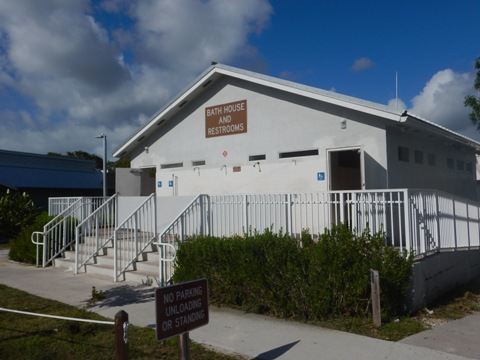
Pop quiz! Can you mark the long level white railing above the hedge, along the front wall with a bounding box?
[208,190,405,246]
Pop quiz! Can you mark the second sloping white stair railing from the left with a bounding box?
[75,194,118,274]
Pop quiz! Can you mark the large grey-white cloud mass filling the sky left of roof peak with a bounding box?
[0,0,272,153]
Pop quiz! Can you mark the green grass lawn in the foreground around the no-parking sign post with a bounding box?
[0,285,241,360]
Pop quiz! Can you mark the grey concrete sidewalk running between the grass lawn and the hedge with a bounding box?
[0,251,480,360]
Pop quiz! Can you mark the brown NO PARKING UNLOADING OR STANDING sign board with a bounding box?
[155,279,208,341]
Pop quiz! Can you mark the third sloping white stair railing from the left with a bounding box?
[113,194,157,281]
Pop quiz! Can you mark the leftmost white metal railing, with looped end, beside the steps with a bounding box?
[31,197,103,267]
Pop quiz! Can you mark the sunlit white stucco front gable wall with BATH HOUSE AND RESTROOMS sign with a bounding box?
[132,78,387,196]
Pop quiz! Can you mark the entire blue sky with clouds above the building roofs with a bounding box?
[0,0,480,159]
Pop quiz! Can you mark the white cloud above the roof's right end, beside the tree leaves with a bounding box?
[409,69,479,139]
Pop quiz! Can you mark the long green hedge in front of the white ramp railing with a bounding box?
[174,225,413,320]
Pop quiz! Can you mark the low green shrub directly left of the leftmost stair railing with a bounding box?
[9,212,53,264]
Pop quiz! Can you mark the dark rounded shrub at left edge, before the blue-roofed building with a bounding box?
[0,189,37,240]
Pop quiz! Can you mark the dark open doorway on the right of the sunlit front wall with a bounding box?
[328,147,365,191]
